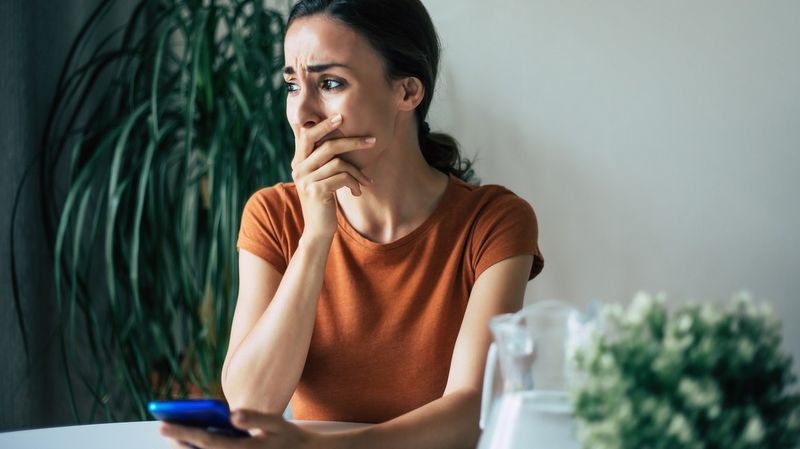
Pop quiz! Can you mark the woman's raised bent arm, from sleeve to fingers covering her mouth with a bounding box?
[222,115,375,413]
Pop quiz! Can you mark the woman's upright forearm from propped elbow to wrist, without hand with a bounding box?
[222,235,331,413]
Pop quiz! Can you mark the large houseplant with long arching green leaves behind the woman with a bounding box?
[12,0,293,421]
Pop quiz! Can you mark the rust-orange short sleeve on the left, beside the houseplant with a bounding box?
[236,187,288,274]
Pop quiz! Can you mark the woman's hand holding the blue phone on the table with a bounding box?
[161,410,328,449]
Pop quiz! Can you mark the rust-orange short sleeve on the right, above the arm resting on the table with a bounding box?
[472,191,544,280]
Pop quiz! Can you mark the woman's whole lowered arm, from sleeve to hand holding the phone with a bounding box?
[161,256,533,449]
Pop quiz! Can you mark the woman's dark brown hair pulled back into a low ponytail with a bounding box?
[287,0,474,181]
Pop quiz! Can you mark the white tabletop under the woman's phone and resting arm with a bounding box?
[0,421,368,449]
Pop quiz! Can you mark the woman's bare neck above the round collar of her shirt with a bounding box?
[336,132,449,243]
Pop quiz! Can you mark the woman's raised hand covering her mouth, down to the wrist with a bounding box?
[292,114,375,237]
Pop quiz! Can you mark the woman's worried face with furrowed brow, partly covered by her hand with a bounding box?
[284,15,402,169]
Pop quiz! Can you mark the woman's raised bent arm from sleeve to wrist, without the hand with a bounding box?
[222,237,331,413]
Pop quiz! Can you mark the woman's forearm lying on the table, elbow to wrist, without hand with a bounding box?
[332,389,481,449]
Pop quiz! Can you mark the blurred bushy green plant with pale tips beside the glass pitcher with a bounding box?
[572,293,800,449]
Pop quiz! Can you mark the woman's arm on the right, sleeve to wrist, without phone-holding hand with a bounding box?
[332,256,533,449]
